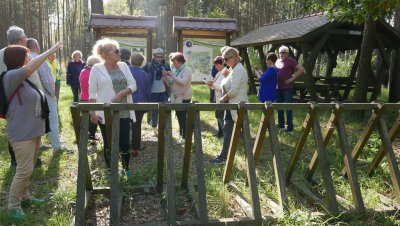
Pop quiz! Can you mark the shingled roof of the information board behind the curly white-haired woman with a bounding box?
[89,14,157,30]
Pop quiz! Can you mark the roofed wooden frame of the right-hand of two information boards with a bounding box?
[173,16,238,52]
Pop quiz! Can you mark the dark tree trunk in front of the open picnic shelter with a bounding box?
[353,18,376,103]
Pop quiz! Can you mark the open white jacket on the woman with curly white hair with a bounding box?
[89,62,137,124]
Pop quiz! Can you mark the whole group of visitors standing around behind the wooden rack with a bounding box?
[0,23,304,220]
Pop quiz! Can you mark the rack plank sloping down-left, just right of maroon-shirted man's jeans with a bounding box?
[285,103,317,185]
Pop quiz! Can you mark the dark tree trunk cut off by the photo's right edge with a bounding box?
[389,7,400,103]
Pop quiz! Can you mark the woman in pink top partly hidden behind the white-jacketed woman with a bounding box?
[79,55,101,141]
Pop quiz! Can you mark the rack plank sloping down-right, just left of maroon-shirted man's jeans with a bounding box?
[267,105,289,213]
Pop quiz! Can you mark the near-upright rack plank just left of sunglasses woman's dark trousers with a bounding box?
[192,108,208,224]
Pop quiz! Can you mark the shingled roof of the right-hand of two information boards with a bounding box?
[174,16,238,33]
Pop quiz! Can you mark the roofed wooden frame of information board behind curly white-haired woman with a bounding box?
[89,14,157,62]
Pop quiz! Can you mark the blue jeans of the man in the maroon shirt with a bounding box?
[276,88,293,130]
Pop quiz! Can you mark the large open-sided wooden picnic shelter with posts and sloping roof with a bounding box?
[231,13,400,101]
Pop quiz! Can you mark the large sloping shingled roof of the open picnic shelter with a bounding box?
[231,13,400,50]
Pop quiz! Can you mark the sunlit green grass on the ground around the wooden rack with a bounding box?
[0,83,400,225]
